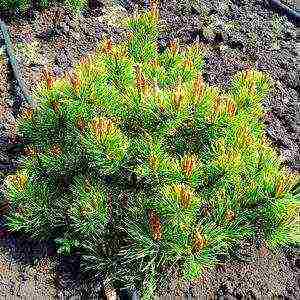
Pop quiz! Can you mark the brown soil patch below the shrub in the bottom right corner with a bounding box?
[158,242,300,300]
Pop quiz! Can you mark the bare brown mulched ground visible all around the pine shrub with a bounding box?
[0,0,300,299]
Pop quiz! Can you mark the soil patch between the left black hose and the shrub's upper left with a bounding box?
[9,7,125,93]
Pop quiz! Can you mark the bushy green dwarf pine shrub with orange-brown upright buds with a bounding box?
[1,4,299,295]
